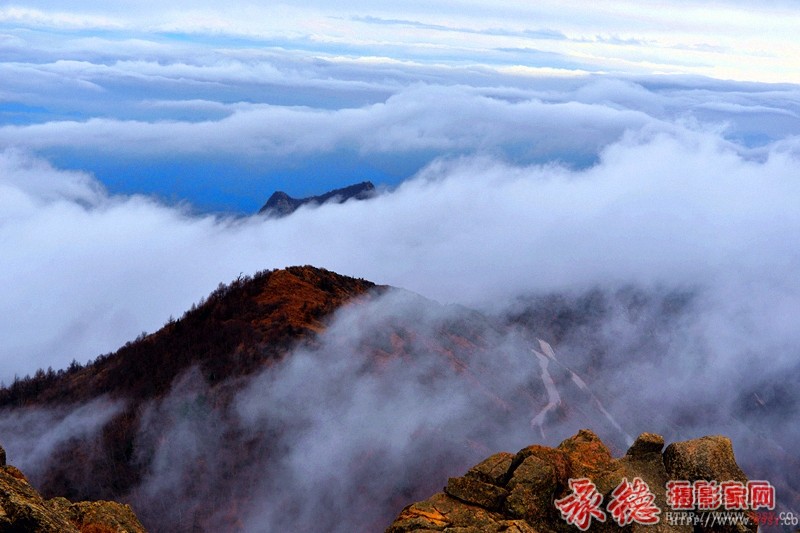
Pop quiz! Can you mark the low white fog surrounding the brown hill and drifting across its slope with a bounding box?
[0,123,800,531]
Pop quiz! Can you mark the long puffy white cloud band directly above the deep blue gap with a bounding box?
[0,85,652,166]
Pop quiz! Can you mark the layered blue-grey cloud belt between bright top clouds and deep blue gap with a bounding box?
[6,51,800,171]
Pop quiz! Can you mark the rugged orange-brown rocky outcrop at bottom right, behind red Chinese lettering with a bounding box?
[386,430,757,533]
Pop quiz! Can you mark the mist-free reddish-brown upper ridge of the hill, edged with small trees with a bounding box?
[0,266,382,407]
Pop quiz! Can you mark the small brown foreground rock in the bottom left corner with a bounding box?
[0,442,145,533]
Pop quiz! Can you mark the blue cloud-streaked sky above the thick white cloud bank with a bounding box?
[0,1,800,210]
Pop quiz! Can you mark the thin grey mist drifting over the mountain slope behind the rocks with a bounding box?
[115,272,800,532]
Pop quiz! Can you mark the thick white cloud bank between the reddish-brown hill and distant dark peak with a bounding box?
[0,112,800,382]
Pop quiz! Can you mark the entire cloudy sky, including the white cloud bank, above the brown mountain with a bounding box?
[0,0,800,528]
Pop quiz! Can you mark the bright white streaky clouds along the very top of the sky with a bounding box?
[0,0,798,82]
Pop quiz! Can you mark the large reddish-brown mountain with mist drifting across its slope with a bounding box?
[0,266,798,533]
